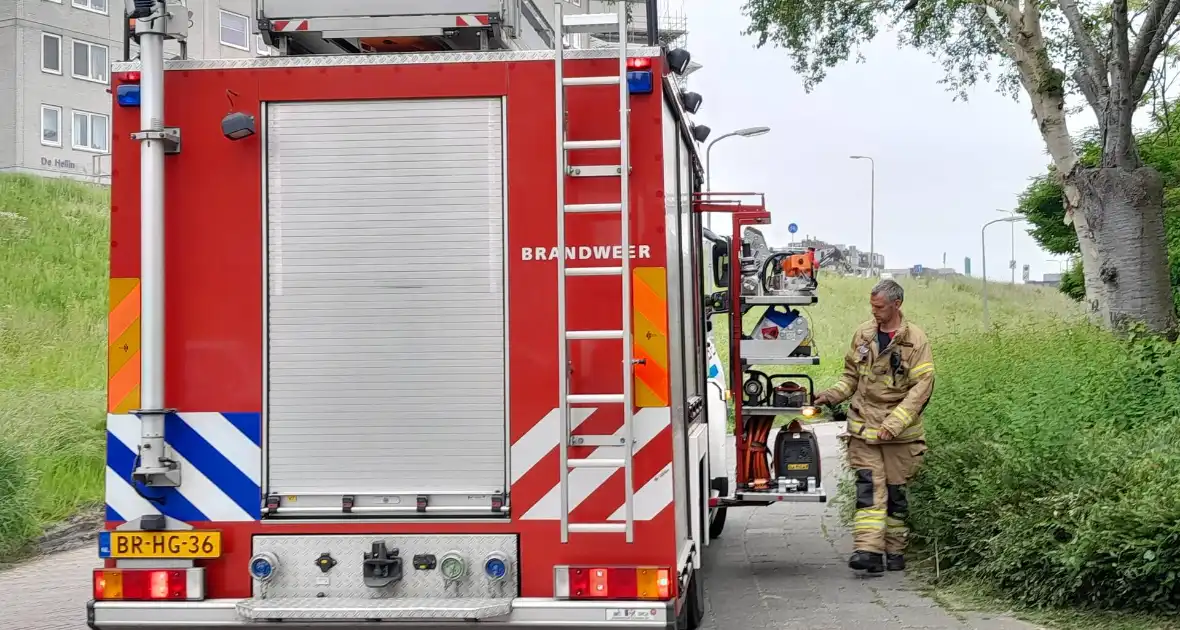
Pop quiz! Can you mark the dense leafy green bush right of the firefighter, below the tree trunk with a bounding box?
[911,323,1180,612]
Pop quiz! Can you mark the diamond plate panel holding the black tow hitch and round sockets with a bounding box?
[254,534,519,599]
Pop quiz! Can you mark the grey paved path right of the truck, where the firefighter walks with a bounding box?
[704,424,1036,630]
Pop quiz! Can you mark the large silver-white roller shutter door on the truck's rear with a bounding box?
[266,99,506,496]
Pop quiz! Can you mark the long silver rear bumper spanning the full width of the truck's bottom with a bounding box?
[86,598,676,630]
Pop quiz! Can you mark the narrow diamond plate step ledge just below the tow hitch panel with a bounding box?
[237,597,512,621]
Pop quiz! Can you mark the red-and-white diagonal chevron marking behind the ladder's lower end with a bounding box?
[511,407,673,521]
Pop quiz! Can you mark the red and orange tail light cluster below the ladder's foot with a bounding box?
[555,566,676,599]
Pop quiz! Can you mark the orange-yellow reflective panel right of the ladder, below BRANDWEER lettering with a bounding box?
[631,267,670,407]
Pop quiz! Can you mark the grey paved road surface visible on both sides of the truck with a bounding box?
[0,425,1034,630]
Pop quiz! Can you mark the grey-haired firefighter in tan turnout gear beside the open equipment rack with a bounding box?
[815,280,935,573]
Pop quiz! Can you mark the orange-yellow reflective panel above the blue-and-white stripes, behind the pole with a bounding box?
[106,277,140,413]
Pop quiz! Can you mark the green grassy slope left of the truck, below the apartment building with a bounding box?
[0,175,109,559]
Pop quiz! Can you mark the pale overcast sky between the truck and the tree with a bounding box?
[666,0,1082,282]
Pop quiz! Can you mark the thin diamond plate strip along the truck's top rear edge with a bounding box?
[111,47,660,72]
